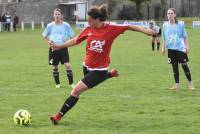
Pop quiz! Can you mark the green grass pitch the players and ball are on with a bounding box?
[0,26,200,134]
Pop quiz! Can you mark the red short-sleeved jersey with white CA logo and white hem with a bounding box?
[76,23,128,70]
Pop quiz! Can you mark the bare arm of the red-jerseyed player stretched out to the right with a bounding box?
[128,26,157,36]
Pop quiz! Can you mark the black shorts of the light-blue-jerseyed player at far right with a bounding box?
[168,49,189,64]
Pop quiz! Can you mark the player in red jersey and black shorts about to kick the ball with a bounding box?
[50,5,156,125]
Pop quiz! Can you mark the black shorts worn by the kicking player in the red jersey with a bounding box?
[81,66,109,88]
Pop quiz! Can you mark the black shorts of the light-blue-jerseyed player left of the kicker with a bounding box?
[49,48,69,65]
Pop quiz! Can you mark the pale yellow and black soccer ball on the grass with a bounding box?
[13,109,31,126]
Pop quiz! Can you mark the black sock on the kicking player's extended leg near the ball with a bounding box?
[59,95,79,116]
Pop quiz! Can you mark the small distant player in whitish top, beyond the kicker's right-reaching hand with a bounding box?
[149,20,162,51]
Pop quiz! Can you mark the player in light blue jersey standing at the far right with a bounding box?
[162,8,195,90]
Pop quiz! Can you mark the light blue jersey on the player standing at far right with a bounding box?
[163,22,187,52]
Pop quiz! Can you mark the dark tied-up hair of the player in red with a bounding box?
[88,4,108,21]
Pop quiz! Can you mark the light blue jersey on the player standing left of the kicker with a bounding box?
[42,22,74,45]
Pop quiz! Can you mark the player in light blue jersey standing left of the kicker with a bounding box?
[42,8,74,88]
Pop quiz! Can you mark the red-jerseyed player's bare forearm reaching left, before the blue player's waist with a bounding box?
[51,37,78,50]
